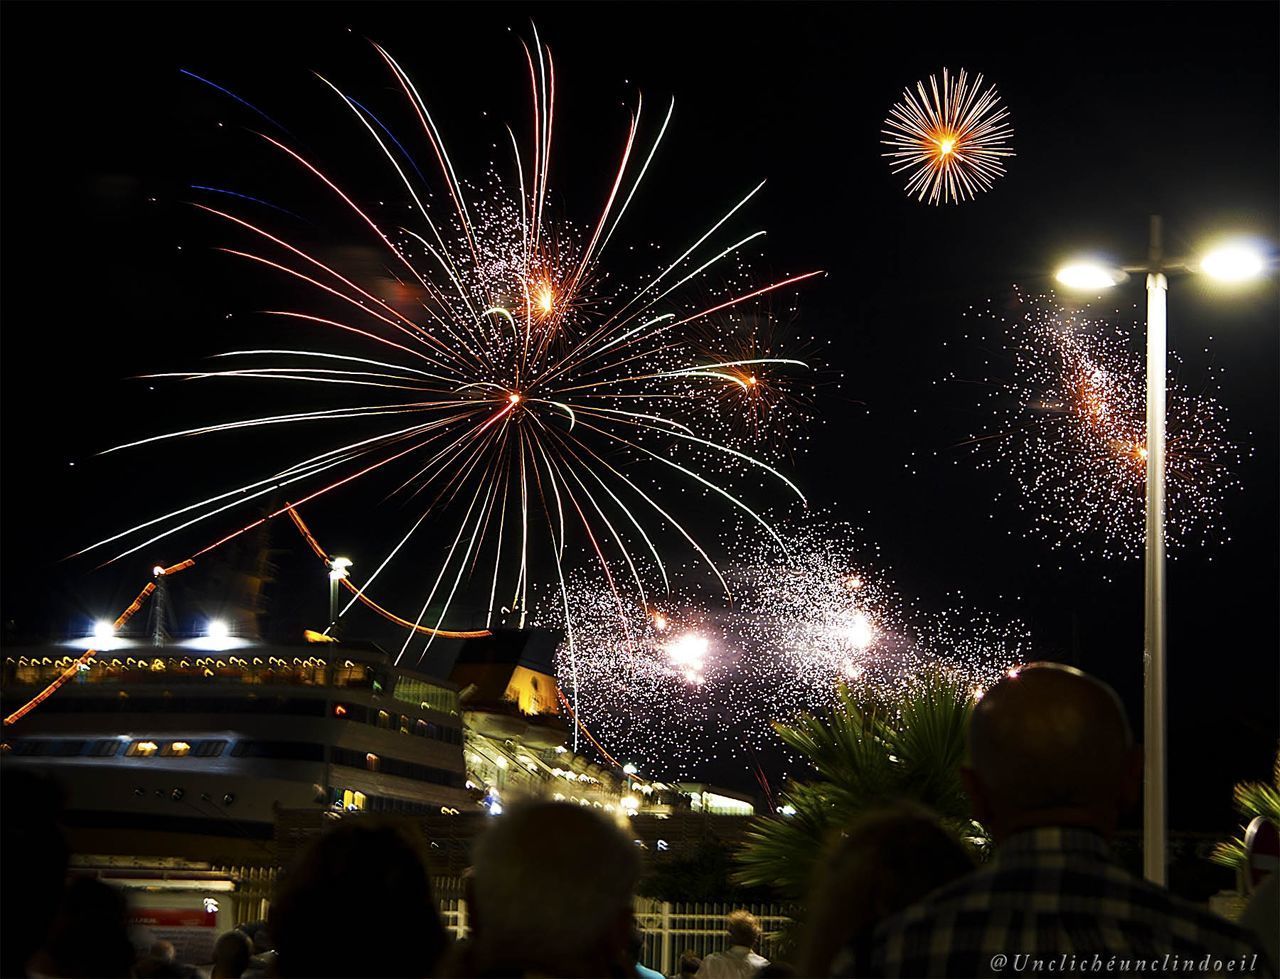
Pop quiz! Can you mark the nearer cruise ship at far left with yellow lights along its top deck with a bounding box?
[0,637,475,863]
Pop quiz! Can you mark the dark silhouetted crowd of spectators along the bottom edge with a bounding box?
[0,663,1280,979]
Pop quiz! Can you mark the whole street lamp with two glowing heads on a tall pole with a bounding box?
[1055,215,1266,886]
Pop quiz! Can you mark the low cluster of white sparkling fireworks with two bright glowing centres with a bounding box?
[535,514,1030,777]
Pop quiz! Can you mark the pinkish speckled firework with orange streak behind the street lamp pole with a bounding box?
[972,296,1242,558]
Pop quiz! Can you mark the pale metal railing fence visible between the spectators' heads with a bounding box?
[440,895,791,975]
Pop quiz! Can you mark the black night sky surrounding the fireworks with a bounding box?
[0,3,1280,829]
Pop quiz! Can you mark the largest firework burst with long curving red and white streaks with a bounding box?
[82,35,819,690]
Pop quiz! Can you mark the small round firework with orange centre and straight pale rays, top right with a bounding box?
[881,68,1014,203]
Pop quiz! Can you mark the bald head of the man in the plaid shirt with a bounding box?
[968,663,1137,834]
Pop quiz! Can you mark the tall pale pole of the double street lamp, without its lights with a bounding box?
[1142,216,1169,886]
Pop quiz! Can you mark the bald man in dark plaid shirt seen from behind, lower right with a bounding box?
[837,663,1274,976]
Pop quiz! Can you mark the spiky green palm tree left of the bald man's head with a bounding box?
[733,671,986,900]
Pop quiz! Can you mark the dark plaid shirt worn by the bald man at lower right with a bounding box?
[836,827,1274,976]
